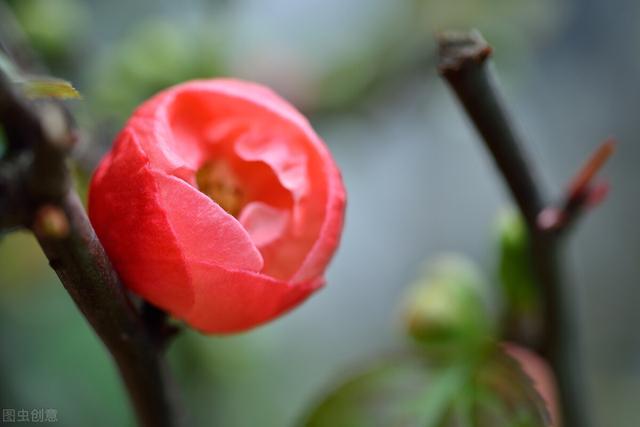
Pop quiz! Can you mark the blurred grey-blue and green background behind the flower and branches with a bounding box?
[0,0,640,427]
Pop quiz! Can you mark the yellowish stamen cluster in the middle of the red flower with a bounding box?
[196,160,246,217]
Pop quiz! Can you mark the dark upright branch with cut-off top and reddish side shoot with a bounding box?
[438,32,612,427]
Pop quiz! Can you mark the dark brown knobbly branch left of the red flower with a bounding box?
[0,74,179,427]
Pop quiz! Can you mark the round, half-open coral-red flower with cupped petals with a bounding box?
[89,80,345,333]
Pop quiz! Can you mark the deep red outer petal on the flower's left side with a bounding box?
[89,132,193,312]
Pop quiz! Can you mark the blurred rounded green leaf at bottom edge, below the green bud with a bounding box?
[301,348,549,427]
